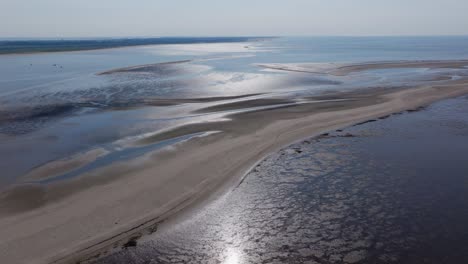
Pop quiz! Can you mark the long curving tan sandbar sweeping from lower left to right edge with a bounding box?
[0,62,468,263]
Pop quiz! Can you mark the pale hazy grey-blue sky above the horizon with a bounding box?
[0,0,468,37]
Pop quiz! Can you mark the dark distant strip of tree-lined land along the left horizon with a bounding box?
[0,37,268,54]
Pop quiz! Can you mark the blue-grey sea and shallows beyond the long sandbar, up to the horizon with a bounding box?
[0,37,468,185]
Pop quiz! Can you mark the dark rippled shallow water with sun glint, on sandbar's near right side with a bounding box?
[98,98,468,264]
